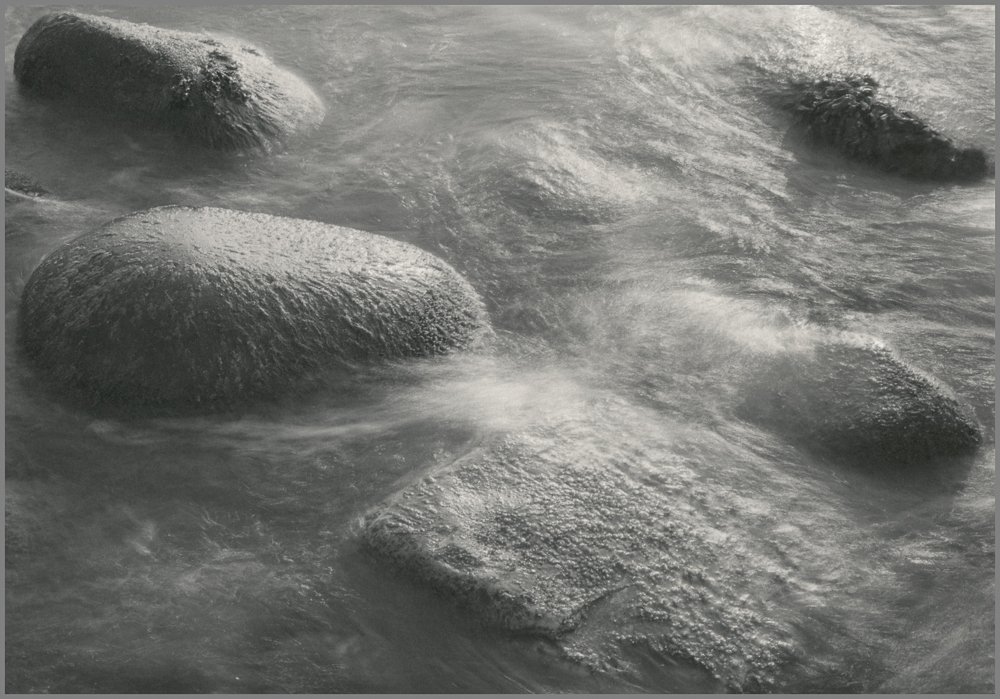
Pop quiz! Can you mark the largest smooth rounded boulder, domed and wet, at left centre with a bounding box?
[19,206,489,412]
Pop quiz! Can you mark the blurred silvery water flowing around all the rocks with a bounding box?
[5,6,995,693]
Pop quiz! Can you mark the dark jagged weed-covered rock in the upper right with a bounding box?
[785,75,994,180]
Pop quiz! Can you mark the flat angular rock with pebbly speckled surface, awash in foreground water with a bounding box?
[359,406,795,690]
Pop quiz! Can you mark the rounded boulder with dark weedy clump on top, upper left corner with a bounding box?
[14,12,325,149]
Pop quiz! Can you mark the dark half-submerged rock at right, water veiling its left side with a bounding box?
[737,342,982,465]
